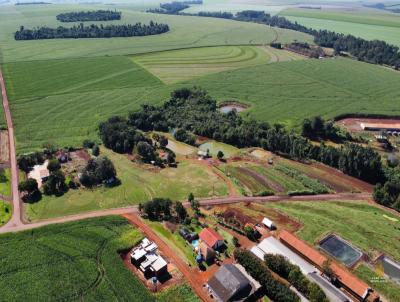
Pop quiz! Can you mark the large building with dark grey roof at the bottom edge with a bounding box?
[207,264,261,302]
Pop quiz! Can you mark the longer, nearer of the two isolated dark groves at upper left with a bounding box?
[14,21,169,40]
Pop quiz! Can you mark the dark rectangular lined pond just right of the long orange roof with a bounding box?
[319,234,362,267]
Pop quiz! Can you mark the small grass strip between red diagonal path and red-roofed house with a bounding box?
[143,219,196,266]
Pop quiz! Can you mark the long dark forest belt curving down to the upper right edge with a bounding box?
[149,2,400,69]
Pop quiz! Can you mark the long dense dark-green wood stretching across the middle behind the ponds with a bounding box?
[127,87,385,183]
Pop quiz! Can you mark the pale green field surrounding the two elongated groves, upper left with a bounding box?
[0,4,311,63]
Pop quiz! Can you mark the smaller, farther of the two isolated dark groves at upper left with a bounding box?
[56,10,122,22]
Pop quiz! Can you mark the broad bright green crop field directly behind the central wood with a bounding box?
[4,53,400,153]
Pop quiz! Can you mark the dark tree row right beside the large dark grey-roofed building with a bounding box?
[234,249,300,302]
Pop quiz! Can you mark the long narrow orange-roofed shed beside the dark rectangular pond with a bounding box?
[279,230,379,302]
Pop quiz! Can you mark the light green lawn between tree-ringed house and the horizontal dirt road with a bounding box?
[26,148,228,220]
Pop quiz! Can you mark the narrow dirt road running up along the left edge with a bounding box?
[0,69,23,230]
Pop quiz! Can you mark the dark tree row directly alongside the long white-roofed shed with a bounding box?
[264,254,329,302]
